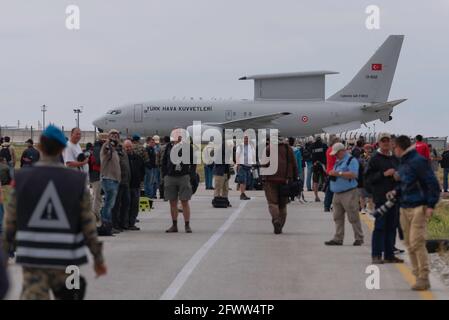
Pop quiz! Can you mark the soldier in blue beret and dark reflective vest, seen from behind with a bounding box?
[3,126,107,300]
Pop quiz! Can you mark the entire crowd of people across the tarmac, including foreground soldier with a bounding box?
[0,126,449,299]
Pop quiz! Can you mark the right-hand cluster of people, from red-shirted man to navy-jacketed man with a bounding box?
[284,133,440,291]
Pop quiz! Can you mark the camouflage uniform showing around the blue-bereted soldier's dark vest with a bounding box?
[3,157,104,300]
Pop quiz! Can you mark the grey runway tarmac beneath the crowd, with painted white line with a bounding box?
[4,187,449,300]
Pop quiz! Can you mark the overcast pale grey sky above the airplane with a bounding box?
[0,0,449,136]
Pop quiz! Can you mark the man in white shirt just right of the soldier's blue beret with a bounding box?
[63,128,90,174]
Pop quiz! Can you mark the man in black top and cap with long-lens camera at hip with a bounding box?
[365,133,404,264]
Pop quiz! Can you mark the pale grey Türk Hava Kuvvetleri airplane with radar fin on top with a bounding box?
[94,35,406,137]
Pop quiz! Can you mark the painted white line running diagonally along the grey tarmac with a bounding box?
[160,201,249,300]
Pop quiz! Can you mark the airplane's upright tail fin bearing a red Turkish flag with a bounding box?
[328,35,404,103]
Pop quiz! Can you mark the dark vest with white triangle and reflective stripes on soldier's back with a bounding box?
[15,166,87,269]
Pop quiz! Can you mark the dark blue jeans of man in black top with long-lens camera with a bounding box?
[371,204,399,259]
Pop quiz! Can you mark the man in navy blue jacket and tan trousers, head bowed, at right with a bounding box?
[394,136,440,291]
